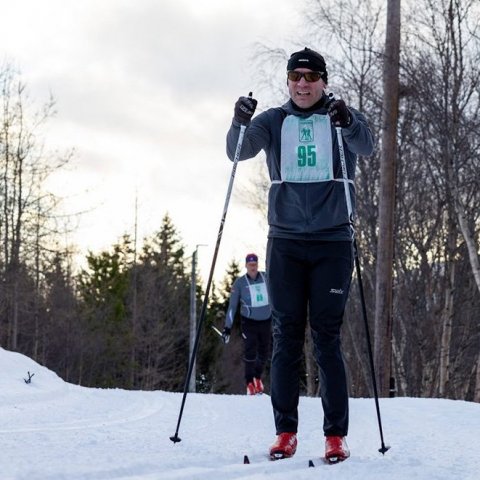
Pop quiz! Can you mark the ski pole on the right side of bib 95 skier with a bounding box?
[335,123,390,455]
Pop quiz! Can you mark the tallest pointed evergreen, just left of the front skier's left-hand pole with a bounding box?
[136,214,190,391]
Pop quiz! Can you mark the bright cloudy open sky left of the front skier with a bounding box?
[0,0,301,279]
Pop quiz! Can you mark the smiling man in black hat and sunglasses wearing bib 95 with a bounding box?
[227,48,374,463]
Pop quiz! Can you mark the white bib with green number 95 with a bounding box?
[281,113,333,183]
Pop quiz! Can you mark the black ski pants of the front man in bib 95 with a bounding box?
[267,238,353,436]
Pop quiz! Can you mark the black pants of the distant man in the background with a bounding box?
[242,315,272,384]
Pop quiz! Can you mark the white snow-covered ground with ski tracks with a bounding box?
[0,349,480,480]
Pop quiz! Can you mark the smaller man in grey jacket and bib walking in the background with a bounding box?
[222,253,272,395]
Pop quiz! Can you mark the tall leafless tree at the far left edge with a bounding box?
[0,65,68,353]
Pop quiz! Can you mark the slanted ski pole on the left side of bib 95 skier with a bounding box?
[170,98,252,443]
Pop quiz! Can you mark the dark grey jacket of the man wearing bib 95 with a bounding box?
[227,95,374,241]
